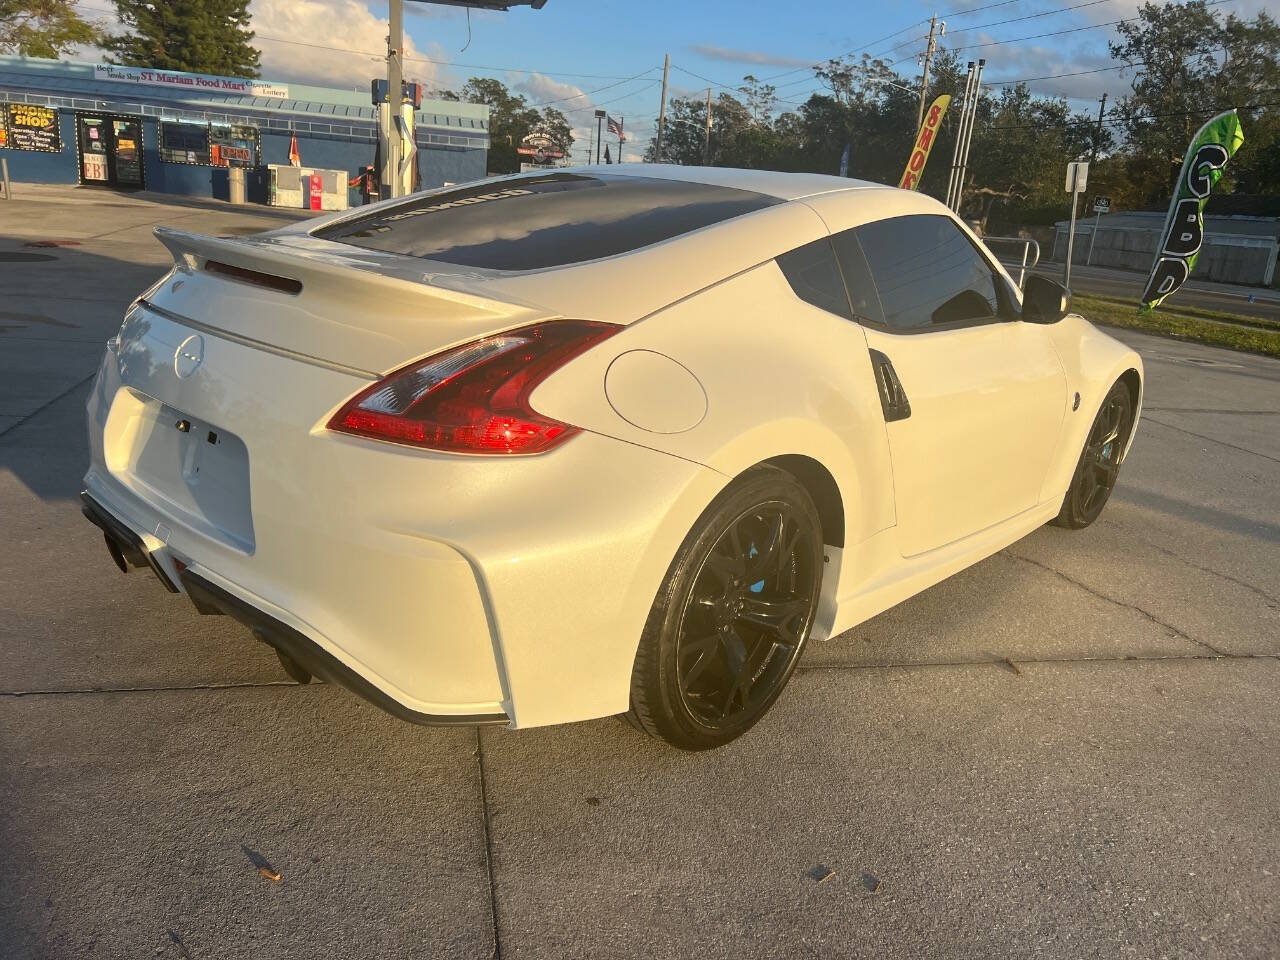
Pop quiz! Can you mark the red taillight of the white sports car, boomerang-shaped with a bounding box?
[329,320,622,453]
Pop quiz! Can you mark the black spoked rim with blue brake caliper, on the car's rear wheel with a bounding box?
[676,500,819,730]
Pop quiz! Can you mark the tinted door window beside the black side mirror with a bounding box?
[856,215,1000,330]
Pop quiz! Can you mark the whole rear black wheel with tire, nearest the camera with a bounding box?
[627,468,823,750]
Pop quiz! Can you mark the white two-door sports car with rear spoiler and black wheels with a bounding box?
[83,164,1142,749]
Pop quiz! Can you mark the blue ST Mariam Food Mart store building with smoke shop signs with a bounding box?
[0,56,489,204]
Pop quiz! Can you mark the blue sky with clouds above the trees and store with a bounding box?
[72,0,1268,159]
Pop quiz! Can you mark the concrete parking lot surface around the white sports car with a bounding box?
[0,188,1280,960]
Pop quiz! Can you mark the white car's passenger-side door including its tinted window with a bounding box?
[833,214,1066,557]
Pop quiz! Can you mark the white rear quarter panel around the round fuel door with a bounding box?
[531,260,893,544]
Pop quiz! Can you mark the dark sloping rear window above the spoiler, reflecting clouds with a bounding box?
[315,173,781,270]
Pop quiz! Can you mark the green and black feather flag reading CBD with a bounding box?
[1142,110,1244,314]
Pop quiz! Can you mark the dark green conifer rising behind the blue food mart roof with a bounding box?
[104,0,260,77]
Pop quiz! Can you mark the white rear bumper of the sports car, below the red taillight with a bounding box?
[84,315,727,727]
